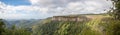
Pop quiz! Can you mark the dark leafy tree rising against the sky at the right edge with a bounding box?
[112,0,120,20]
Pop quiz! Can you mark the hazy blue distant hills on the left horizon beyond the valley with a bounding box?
[3,19,41,28]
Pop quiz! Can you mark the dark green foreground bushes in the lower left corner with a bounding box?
[0,19,31,35]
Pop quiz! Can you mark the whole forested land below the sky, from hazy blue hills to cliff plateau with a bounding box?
[1,14,120,35]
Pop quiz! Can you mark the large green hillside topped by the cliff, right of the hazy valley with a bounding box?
[33,15,120,35]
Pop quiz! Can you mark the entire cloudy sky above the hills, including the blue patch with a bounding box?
[0,0,112,19]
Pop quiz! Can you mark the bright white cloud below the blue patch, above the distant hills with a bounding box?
[0,2,43,19]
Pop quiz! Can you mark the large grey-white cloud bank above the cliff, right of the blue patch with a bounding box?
[30,0,112,14]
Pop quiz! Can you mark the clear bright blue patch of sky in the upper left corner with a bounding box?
[0,0,31,6]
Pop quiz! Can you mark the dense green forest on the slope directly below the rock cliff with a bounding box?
[33,21,86,35]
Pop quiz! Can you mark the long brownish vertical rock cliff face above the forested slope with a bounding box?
[52,16,87,21]
